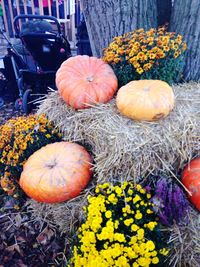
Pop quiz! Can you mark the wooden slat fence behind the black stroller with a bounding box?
[1,0,80,46]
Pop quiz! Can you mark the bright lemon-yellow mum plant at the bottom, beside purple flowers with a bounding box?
[69,182,169,267]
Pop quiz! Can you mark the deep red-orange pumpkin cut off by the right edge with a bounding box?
[181,158,200,211]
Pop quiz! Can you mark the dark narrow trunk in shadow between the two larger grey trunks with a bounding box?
[157,0,172,26]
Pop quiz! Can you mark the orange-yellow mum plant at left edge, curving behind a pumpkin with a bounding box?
[0,115,60,194]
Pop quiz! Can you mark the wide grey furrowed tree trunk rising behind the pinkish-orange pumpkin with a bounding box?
[81,0,157,56]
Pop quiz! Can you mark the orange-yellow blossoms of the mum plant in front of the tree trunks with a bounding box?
[103,27,187,74]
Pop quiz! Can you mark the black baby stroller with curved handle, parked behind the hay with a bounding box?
[1,15,71,114]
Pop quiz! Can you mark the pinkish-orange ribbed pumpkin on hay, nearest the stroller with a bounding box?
[56,55,118,109]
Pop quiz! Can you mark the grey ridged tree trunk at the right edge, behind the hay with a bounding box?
[170,0,200,81]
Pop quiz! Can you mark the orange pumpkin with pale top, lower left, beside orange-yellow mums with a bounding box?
[19,142,92,203]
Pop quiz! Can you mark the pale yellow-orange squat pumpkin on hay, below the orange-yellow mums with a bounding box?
[116,80,175,121]
